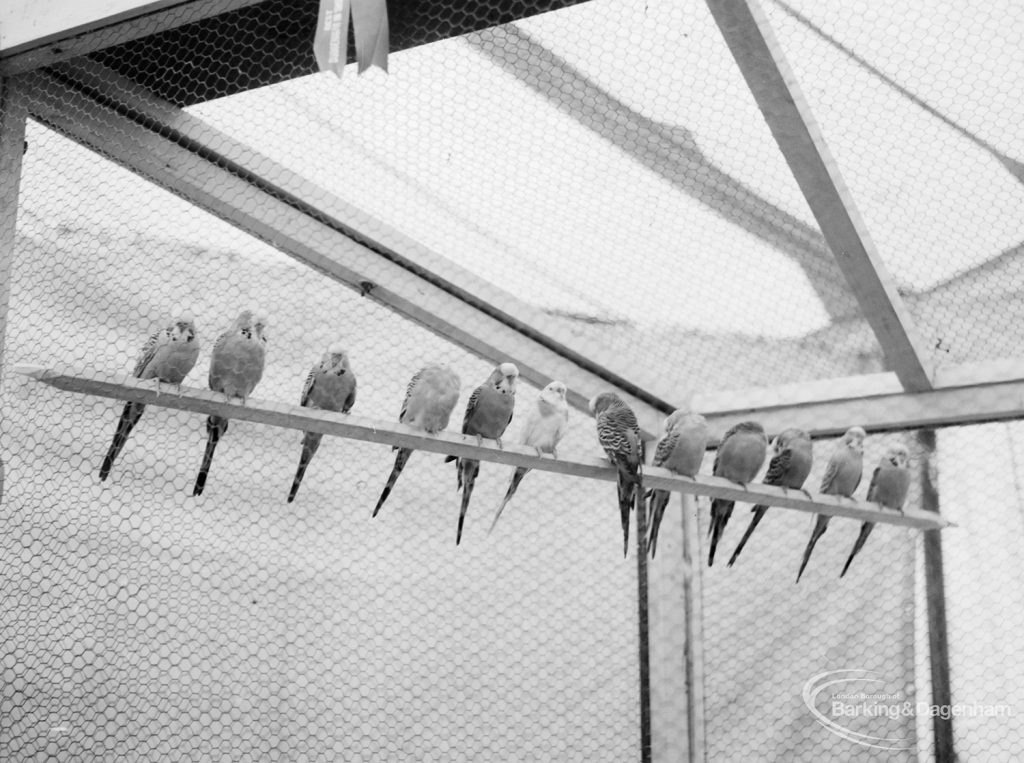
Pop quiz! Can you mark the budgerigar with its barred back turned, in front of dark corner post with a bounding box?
[590,392,646,557]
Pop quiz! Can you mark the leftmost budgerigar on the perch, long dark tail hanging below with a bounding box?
[99,312,199,479]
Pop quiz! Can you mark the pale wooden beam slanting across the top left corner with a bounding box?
[0,0,264,75]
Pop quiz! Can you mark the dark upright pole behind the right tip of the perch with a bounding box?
[916,429,956,763]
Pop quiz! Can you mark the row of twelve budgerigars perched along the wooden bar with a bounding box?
[83,310,925,582]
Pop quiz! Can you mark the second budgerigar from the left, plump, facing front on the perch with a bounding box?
[193,310,266,496]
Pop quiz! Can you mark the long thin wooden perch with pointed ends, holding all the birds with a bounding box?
[14,365,951,529]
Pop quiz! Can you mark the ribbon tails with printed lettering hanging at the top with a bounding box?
[313,0,388,77]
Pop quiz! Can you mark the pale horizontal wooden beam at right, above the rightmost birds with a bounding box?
[692,359,1024,437]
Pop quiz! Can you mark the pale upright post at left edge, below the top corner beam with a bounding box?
[0,77,26,384]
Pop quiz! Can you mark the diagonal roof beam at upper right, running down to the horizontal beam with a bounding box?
[708,0,932,392]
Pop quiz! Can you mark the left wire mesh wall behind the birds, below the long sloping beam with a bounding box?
[0,123,639,760]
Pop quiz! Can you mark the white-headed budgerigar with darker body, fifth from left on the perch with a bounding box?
[444,363,519,546]
